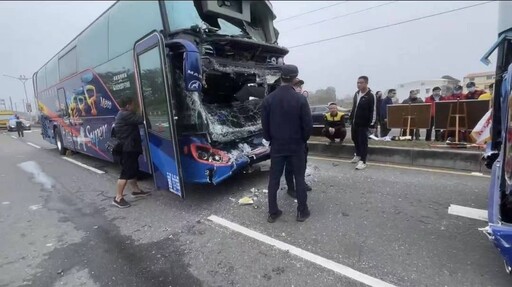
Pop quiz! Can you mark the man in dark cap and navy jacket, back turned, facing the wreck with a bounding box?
[261,65,313,223]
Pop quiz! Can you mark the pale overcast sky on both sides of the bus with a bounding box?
[0,1,498,109]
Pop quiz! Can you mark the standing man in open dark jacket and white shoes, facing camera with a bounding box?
[349,76,377,170]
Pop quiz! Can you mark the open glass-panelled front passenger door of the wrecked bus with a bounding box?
[134,32,185,198]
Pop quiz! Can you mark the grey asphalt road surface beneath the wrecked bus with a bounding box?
[0,131,512,286]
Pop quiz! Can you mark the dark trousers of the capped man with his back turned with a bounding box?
[268,151,308,214]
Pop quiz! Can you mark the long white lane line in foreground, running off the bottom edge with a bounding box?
[208,215,394,287]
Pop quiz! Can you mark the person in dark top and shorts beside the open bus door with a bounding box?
[112,97,150,208]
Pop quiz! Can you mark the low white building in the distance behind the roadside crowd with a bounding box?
[396,76,460,102]
